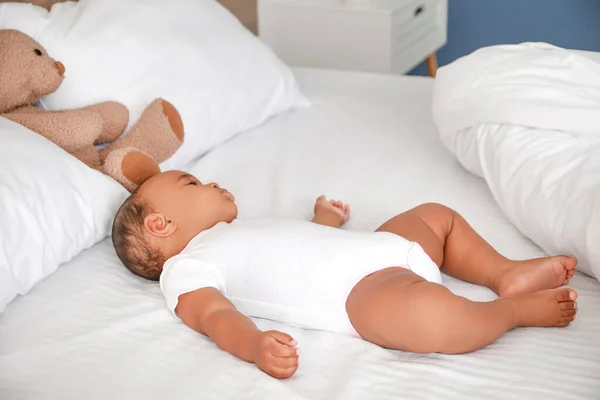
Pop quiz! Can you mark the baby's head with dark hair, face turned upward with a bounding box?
[112,171,237,280]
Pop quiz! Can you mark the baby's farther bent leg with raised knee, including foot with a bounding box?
[377,204,577,296]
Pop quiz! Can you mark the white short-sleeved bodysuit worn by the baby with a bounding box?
[160,219,442,336]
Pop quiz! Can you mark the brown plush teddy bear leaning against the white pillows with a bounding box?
[0,30,183,191]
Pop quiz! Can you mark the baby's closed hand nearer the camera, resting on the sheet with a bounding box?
[253,331,298,379]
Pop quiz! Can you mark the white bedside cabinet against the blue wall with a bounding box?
[258,0,448,74]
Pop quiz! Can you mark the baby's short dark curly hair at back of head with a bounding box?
[112,191,166,281]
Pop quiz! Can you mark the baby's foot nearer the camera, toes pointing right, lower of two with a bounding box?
[506,288,577,327]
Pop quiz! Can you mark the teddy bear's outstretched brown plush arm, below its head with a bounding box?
[3,110,103,153]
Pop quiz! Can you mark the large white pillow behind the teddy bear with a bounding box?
[0,0,307,169]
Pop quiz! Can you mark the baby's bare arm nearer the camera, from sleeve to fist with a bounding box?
[175,288,298,379]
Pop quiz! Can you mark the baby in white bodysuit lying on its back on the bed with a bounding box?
[113,171,577,378]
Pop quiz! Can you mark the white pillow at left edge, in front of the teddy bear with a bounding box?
[0,118,128,312]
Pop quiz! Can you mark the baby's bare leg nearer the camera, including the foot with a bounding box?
[346,268,577,354]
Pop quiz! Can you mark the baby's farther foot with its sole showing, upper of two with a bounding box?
[493,256,577,297]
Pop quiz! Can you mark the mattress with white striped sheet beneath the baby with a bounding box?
[0,69,600,400]
